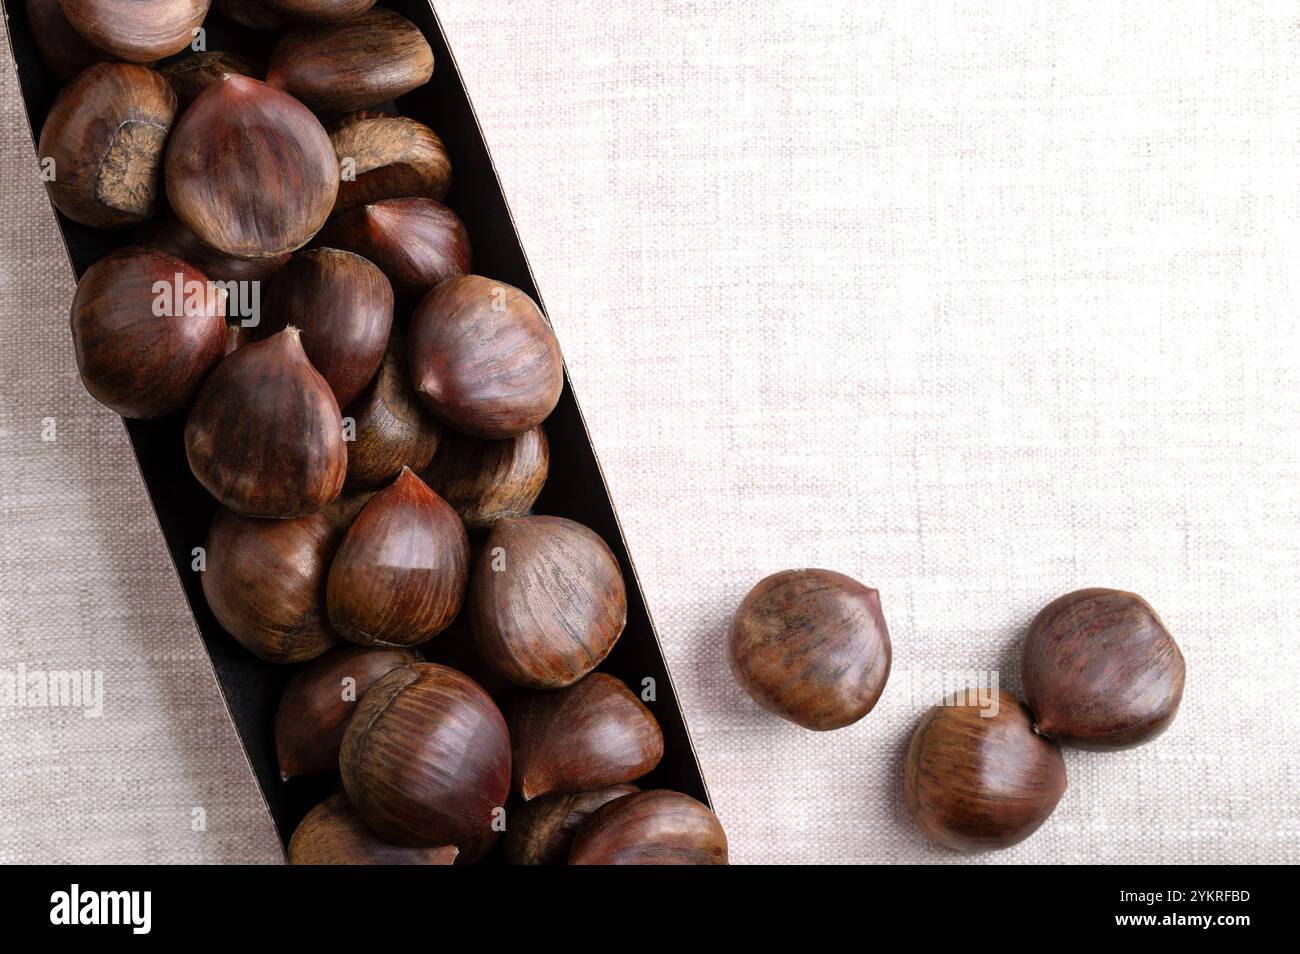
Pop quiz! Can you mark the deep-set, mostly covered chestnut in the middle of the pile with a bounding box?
[343,333,442,487]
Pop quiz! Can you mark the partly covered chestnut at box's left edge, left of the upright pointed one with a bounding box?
[203,507,339,663]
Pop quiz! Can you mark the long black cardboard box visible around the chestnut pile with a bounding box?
[0,0,709,845]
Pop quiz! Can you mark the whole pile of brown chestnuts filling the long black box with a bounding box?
[35,0,727,864]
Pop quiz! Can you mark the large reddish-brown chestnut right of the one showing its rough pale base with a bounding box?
[166,74,338,259]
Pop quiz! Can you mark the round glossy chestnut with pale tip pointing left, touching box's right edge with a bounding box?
[411,276,564,438]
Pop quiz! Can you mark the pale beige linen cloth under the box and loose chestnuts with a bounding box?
[0,0,1300,863]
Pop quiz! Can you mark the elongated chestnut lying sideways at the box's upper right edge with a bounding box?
[267,6,433,113]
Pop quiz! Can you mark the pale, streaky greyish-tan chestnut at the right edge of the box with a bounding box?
[469,517,628,691]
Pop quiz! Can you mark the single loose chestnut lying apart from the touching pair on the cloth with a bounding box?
[727,569,892,732]
